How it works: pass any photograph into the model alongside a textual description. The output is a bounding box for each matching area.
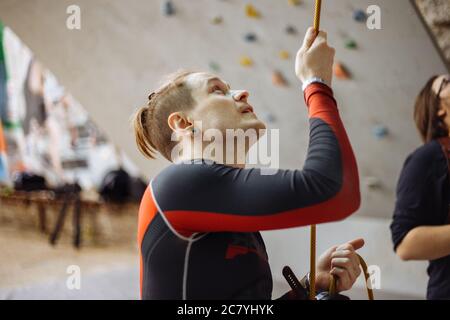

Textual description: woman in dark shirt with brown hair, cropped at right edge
[391,75,450,299]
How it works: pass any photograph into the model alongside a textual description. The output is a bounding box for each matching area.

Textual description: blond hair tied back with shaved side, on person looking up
[132,70,194,161]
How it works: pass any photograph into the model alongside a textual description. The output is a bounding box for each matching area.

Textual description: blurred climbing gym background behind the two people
[0,0,450,299]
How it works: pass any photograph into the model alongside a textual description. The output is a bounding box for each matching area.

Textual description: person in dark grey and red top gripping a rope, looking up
[134,29,363,299]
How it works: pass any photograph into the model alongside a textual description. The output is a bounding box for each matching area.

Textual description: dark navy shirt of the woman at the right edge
[391,141,450,299]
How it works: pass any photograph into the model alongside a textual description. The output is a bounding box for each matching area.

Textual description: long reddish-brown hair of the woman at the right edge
[414,76,448,143]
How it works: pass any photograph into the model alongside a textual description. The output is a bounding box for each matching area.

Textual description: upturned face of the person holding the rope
[186,73,266,137]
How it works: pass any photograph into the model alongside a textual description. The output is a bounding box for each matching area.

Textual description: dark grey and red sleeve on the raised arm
[152,84,360,233]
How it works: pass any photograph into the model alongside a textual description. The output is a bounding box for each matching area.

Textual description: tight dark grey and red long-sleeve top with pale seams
[138,83,360,300]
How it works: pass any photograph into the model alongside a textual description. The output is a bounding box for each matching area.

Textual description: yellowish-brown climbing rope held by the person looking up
[309,0,374,300]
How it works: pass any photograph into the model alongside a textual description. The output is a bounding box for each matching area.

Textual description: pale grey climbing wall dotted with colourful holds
[0,0,447,217]
